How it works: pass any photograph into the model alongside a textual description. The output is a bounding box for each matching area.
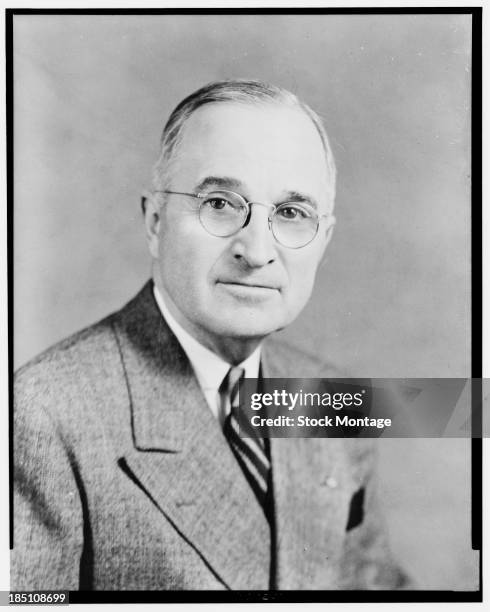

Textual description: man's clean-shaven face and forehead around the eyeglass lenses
[146,103,332,347]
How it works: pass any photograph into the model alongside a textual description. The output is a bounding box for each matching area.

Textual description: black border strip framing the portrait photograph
[5,6,483,604]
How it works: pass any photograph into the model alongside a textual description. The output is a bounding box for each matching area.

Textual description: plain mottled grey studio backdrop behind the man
[14,14,477,589]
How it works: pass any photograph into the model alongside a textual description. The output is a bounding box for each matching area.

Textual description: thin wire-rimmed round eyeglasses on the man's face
[155,190,335,249]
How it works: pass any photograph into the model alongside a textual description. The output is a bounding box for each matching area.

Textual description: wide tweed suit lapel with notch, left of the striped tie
[115,283,270,589]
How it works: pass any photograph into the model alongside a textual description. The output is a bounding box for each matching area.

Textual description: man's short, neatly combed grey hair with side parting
[153,79,337,200]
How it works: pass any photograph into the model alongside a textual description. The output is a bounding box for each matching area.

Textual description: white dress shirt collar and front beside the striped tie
[153,283,260,424]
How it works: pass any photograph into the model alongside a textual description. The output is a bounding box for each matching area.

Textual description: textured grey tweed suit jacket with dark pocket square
[11,283,410,590]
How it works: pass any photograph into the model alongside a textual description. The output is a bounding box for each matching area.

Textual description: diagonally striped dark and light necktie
[219,368,270,511]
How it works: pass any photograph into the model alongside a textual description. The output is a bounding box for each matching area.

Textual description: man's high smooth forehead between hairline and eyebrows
[168,102,330,204]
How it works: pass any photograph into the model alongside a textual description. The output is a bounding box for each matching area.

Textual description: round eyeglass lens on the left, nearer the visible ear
[199,191,247,237]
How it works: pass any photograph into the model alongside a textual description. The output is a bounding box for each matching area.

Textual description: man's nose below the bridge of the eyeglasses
[231,203,277,268]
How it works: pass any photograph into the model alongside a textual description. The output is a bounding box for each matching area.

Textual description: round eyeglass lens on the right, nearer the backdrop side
[272,202,318,249]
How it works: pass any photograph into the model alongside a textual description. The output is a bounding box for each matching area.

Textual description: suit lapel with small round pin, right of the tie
[262,347,355,590]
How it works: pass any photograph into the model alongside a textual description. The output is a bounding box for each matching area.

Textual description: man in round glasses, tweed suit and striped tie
[12,80,410,590]
